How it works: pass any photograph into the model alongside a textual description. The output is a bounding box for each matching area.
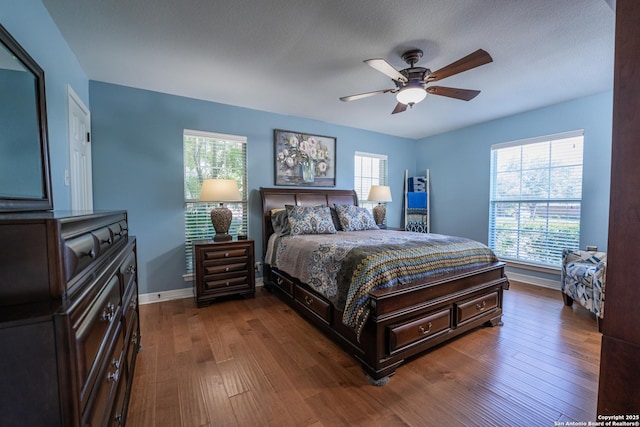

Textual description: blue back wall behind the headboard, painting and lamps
[89,81,416,293]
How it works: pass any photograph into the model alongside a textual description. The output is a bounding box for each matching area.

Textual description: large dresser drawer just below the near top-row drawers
[71,275,122,405]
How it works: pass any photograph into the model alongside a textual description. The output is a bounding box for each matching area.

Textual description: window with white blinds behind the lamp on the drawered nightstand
[183,130,248,274]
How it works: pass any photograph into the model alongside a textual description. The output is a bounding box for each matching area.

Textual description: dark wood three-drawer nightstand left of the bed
[193,240,256,307]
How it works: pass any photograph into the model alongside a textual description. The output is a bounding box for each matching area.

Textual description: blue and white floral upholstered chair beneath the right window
[560,249,607,331]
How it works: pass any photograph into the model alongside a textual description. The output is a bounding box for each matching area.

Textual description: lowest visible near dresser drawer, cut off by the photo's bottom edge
[82,323,126,426]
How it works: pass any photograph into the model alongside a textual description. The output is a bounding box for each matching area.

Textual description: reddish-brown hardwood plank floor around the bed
[127,281,601,427]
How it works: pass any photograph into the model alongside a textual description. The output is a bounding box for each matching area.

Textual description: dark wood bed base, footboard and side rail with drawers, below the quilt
[264,262,509,381]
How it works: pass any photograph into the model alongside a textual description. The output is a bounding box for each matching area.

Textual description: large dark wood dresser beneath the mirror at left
[0,211,140,427]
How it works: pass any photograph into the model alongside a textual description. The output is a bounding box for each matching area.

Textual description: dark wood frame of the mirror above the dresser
[0,24,53,212]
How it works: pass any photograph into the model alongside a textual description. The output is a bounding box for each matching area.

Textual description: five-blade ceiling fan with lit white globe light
[340,49,493,114]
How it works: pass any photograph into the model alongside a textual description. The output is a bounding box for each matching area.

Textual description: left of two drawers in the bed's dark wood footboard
[389,308,451,354]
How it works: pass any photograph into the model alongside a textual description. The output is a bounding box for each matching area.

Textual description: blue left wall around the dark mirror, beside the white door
[0,0,89,210]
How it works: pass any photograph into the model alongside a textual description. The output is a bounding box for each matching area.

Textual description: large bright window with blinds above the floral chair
[489,131,583,267]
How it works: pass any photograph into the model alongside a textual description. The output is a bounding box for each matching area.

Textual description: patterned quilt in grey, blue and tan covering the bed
[265,230,498,337]
